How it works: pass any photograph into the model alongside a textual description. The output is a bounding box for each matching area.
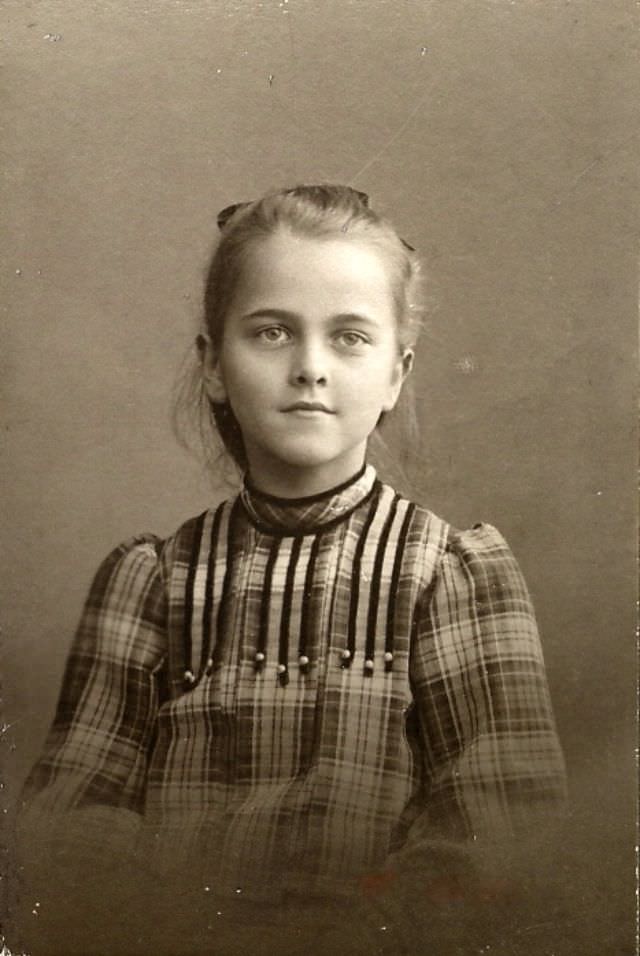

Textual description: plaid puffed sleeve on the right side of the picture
[388,524,566,888]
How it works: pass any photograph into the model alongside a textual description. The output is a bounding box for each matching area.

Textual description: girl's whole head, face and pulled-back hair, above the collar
[178,186,419,493]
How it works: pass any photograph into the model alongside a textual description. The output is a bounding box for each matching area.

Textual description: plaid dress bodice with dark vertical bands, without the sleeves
[146,470,448,898]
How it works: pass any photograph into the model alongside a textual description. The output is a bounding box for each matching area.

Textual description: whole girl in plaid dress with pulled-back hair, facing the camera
[15,186,564,954]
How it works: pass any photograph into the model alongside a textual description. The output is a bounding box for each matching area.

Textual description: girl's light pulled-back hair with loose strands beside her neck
[174,185,421,486]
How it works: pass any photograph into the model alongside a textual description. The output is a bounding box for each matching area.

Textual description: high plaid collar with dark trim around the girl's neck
[240,465,377,534]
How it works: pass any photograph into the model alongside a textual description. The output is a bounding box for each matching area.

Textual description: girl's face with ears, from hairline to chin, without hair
[205,231,412,497]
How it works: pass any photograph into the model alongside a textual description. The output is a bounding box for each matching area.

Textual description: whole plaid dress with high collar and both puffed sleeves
[24,466,565,899]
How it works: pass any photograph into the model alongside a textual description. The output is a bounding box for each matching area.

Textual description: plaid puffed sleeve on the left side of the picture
[18,535,166,872]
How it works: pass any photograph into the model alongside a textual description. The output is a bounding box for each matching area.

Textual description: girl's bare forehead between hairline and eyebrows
[234,231,393,311]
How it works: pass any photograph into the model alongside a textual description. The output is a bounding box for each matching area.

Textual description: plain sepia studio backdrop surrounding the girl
[0,0,639,956]
